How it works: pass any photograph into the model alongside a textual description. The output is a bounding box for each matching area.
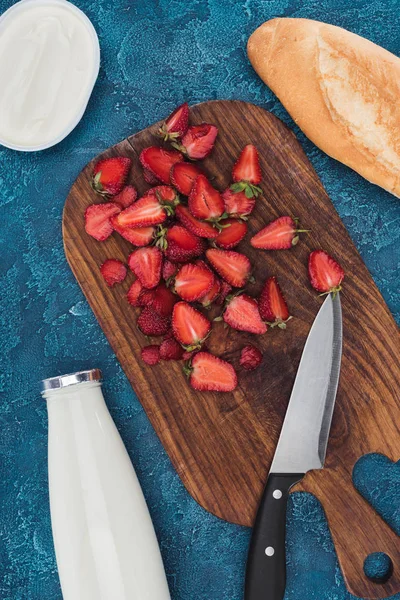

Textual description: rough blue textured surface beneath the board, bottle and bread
[0,0,400,600]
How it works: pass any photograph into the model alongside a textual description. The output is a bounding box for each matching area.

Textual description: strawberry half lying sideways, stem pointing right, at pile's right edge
[250,216,308,250]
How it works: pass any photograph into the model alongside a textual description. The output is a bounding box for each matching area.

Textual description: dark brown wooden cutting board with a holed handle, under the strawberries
[63,101,400,598]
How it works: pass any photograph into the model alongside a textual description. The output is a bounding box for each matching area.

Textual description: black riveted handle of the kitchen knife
[244,473,304,600]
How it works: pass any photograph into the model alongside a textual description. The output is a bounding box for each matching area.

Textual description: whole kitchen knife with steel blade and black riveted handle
[245,294,342,600]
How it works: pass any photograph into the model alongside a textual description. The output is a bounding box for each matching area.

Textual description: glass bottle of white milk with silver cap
[42,369,170,600]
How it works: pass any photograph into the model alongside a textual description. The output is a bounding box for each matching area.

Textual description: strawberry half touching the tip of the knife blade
[308,250,344,297]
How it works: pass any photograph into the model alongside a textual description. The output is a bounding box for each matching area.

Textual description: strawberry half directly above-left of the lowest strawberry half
[172,302,211,351]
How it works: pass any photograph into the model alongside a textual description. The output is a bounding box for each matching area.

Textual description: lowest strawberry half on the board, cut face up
[185,352,237,392]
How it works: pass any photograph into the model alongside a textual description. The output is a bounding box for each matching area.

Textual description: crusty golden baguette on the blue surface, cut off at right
[247,19,400,196]
